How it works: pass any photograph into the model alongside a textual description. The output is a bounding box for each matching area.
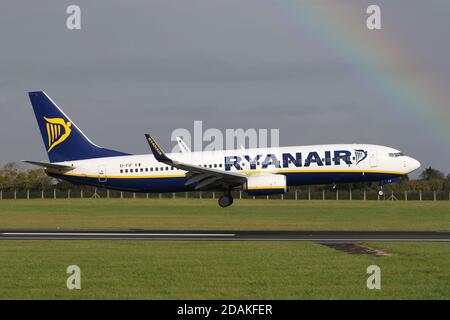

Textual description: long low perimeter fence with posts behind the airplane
[0,188,450,201]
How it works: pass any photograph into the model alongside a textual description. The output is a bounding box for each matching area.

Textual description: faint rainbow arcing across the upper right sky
[274,0,450,155]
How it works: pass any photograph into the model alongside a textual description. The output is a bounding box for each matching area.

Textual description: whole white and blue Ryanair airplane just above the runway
[24,91,420,207]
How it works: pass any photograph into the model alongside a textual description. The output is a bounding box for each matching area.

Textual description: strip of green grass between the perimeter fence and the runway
[0,199,450,231]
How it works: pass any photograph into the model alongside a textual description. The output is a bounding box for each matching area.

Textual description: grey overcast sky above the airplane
[0,0,450,173]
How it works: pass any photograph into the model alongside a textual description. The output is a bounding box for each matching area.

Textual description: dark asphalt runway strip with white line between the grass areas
[0,230,450,243]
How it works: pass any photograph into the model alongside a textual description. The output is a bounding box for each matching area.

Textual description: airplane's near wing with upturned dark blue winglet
[145,134,247,189]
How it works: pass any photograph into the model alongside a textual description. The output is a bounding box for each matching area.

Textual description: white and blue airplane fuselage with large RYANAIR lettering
[46,144,420,193]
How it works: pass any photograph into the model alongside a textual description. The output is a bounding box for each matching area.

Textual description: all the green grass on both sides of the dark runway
[0,199,450,299]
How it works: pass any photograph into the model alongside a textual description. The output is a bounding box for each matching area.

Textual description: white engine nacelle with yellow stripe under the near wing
[244,174,287,196]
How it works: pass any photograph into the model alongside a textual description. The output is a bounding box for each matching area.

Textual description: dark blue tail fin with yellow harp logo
[28,91,127,162]
